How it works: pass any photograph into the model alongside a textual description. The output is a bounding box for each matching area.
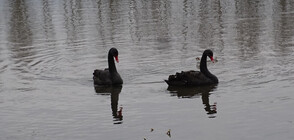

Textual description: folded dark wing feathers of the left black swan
[93,69,111,85]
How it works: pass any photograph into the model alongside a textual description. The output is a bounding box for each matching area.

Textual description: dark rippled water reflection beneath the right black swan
[167,85,217,118]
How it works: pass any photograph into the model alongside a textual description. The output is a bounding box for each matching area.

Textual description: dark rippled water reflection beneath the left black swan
[94,85,123,124]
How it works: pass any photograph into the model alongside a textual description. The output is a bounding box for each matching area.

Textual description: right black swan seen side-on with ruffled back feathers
[165,49,218,86]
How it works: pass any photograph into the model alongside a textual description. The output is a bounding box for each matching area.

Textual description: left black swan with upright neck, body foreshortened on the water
[93,48,123,85]
